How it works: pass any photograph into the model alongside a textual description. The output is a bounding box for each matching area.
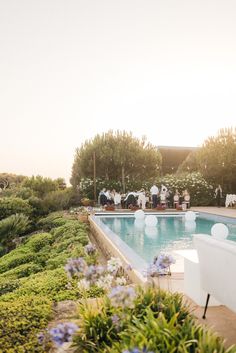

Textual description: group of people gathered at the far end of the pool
[98,184,190,209]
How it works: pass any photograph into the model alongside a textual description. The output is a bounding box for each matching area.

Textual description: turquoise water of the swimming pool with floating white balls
[100,216,236,263]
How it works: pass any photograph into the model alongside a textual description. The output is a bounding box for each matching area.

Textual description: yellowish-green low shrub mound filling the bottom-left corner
[0,296,52,353]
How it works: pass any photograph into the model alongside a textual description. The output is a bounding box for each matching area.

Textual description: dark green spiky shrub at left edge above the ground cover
[0,214,29,251]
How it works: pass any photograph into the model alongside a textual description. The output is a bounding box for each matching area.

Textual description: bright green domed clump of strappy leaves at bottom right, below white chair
[109,308,235,353]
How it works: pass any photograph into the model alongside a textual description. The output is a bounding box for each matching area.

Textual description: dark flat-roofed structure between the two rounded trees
[158,146,198,175]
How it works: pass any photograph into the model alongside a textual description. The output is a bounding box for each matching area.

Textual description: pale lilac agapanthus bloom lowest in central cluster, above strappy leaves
[108,286,136,308]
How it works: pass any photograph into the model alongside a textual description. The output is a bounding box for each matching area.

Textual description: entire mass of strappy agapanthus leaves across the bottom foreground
[74,288,235,353]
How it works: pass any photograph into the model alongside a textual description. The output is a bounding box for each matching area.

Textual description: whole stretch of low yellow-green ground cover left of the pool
[0,210,96,353]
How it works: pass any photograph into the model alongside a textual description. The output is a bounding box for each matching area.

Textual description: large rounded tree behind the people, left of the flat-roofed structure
[71,131,161,190]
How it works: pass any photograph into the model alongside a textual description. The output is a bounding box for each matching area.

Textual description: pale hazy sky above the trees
[0,0,236,182]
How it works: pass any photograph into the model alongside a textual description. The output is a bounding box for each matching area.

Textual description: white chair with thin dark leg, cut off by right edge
[193,234,236,319]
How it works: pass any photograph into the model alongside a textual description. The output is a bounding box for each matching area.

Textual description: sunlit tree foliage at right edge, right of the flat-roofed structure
[180,128,236,193]
